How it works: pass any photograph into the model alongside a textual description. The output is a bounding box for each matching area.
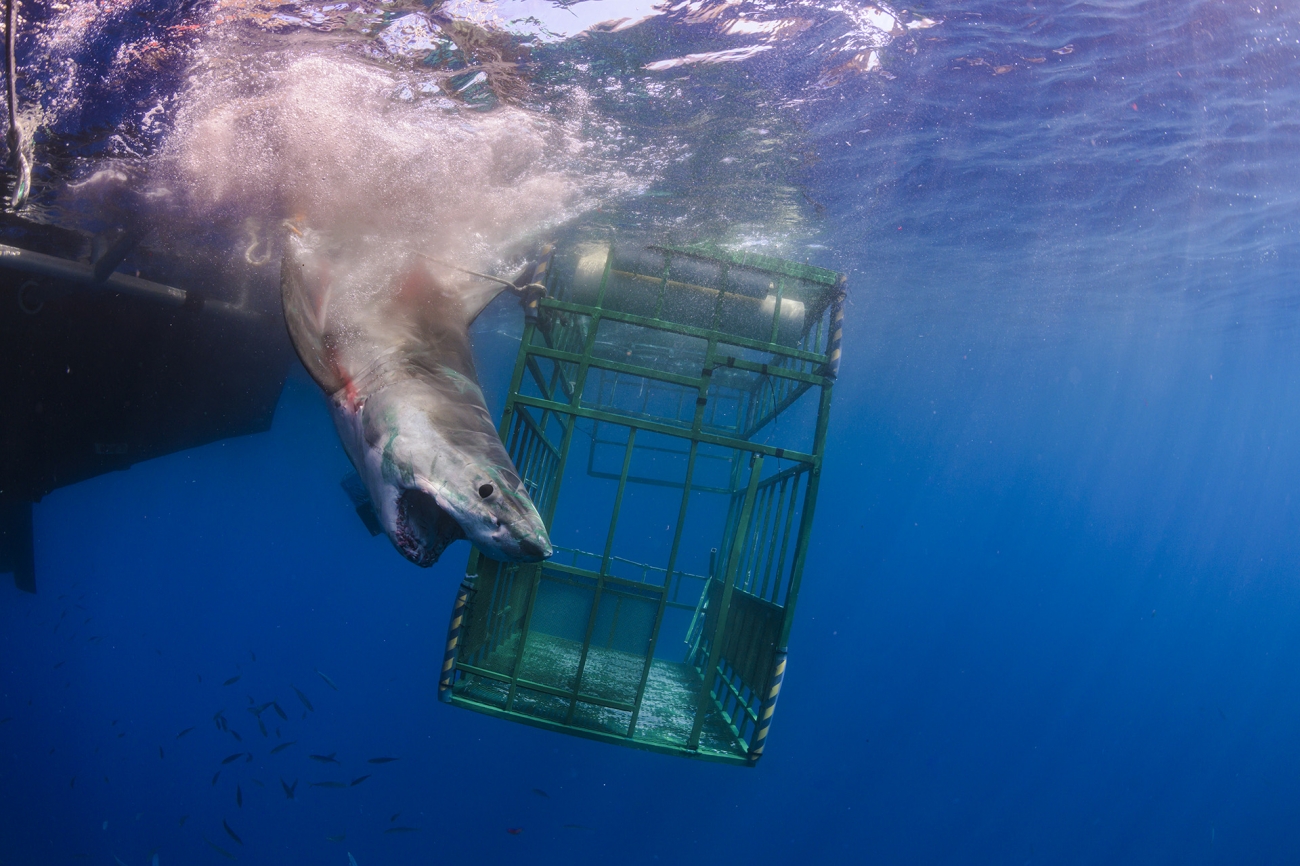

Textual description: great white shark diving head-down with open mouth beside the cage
[281,230,551,567]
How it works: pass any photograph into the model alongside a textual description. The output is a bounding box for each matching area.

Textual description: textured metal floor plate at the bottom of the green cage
[456,633,744,755]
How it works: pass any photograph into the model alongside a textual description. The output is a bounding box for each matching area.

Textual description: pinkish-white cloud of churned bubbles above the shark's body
[161,53,584,267]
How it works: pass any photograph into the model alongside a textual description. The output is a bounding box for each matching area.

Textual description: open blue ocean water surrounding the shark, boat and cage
[0,0,1300,866]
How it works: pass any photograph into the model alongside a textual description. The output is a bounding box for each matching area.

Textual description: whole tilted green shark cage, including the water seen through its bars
[438,242,845,765]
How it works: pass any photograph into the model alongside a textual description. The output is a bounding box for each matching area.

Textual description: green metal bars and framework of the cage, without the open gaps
[438,242,846,766]
